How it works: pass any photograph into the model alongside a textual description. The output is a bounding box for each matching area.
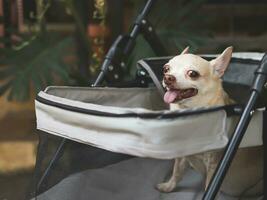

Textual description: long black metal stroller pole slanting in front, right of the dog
[202,54,267,200]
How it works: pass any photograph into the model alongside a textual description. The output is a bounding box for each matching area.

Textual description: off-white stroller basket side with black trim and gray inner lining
[36,87,262,159]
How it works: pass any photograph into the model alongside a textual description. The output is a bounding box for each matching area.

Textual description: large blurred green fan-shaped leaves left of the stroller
[0,0,89,101]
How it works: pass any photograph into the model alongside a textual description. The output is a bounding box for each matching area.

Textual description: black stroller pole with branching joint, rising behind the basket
[92,0,167,86]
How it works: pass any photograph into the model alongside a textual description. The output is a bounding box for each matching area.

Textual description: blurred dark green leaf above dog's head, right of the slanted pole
[151,0,208,50]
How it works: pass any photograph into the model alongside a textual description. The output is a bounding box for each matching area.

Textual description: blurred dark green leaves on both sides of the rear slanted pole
[128,0,209,76]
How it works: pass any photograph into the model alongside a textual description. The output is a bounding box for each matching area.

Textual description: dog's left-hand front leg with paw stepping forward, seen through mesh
[157,157,187,192]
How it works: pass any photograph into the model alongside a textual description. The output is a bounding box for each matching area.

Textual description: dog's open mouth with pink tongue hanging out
[164,88,198,103]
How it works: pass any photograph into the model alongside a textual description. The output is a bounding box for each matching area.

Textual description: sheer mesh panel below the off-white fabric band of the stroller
[27,132,262,200]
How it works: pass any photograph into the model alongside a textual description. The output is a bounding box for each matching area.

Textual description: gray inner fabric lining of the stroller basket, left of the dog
[45,86,168,110]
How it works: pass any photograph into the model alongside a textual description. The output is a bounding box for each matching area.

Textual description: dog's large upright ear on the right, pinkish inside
[210,47,233,77]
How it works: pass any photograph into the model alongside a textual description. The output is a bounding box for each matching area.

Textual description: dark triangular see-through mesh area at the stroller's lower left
[29,131,131,198]
